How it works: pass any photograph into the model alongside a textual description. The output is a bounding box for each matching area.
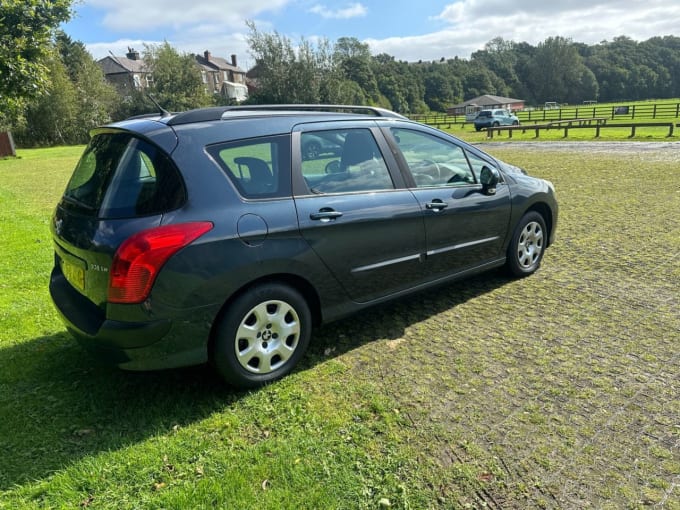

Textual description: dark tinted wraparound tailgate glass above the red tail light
[64,133,186,219]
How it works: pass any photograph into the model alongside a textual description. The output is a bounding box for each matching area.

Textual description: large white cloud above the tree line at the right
[364,0,680,61]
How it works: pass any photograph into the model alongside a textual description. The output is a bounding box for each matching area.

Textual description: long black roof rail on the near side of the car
[168,104,406,126]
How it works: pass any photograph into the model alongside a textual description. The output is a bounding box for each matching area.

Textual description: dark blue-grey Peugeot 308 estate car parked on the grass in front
[50,105,557,387]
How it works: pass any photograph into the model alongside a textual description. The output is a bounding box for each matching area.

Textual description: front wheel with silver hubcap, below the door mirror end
[507,211,547,277]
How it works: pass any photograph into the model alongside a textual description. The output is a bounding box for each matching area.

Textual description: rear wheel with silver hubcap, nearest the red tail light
[211,283,312,388]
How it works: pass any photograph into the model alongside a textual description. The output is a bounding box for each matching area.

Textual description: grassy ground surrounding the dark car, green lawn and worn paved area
[0,141,680,509]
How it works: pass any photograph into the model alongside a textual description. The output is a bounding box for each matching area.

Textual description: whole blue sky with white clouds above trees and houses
[64,0,680,68]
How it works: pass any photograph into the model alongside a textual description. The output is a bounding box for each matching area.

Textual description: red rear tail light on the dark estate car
[108,221,213,303]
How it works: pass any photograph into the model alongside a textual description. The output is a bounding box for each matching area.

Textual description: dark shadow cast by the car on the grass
[0,271,511,490]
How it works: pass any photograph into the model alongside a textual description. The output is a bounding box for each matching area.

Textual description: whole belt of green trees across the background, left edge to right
[0,0,680,146]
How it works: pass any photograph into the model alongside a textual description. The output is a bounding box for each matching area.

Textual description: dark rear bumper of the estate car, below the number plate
[50,268,216,370]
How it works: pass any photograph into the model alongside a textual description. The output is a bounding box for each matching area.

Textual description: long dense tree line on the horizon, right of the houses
[249,29,680,114]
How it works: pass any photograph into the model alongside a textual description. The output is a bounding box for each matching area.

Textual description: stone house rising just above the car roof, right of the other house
[195,50,248,102]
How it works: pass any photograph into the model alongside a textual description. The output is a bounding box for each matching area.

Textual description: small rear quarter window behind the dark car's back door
[208,135,291,198]
